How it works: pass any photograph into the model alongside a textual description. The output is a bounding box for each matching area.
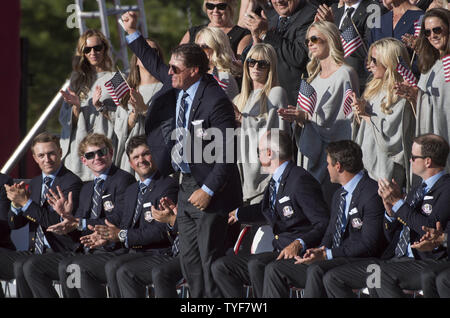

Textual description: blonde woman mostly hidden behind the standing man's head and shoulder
[195,27,242,100]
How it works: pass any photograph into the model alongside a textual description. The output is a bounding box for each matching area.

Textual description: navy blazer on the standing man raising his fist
[129,36,242,213]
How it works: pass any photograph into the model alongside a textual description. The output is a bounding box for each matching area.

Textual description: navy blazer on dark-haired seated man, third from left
[107,172,178,250]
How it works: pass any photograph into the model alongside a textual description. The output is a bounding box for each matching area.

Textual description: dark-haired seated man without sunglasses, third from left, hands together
[48,136,178,298]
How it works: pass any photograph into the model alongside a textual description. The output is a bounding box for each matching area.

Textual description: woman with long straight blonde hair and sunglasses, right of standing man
[233,43,289,204]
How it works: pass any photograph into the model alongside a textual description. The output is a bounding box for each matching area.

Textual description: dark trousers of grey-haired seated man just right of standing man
[212,252,279,298]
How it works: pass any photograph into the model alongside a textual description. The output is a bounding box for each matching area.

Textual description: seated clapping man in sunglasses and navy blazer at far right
[324,134,450,297]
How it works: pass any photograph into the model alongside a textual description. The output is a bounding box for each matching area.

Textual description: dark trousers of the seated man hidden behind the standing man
[117,255,183,298]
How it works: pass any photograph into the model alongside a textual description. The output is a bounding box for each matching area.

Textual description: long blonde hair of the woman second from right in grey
[363,38,411,114]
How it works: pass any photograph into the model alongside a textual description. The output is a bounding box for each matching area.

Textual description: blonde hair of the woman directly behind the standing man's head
[195,27,241,76]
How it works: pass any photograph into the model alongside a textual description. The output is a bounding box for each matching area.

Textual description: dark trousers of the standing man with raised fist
[177,175,230,298]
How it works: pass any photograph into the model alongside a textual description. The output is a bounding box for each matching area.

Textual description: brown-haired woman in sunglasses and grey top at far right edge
[397,8,450,169]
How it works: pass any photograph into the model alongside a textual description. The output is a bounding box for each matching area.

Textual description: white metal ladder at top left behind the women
[75,0,147,72]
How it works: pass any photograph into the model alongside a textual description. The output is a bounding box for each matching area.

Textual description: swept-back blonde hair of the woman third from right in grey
[306,21,344,83]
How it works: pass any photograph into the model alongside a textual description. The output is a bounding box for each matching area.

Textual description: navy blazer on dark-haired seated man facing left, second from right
[321,172,386,258]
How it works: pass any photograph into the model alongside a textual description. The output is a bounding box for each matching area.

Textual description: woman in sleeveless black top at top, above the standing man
[180,0,251,58]
